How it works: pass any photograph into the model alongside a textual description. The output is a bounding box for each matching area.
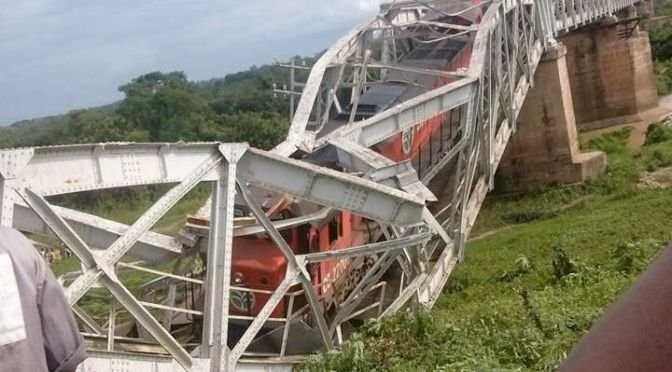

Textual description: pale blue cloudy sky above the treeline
[0,0,383,126]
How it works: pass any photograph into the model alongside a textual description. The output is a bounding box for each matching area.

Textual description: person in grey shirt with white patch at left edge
[0,227,86,372]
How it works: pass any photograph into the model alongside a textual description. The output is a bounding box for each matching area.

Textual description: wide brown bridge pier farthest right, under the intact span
[561,22,658,130]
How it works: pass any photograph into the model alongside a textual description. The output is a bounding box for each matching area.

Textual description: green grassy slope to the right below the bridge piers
[302,126,672,371]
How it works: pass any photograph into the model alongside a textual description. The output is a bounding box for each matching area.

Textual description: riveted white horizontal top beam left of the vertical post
[9,143,219,196]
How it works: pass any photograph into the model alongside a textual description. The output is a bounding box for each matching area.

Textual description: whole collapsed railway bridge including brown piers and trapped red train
[0,0,657,372]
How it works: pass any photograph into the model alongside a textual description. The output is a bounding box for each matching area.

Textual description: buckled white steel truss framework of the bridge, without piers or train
[0,0,638,371]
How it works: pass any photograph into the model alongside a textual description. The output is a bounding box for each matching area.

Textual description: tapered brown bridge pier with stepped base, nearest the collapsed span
[495,44,607,191]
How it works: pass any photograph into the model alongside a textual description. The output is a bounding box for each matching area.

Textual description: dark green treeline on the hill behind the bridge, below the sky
[0,57,313,149]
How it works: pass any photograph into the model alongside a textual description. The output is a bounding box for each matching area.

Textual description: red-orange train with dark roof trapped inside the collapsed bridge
[181,1,481,346]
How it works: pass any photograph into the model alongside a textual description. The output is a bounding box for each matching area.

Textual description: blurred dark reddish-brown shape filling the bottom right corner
[560,246,672,372]
